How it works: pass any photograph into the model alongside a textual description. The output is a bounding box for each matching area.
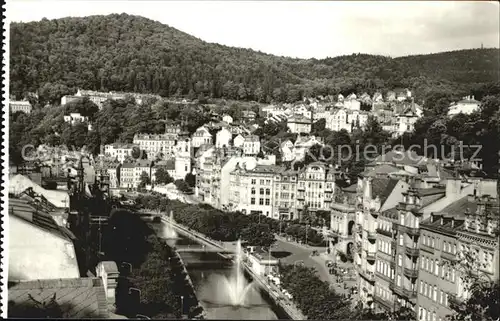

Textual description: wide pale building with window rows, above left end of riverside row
[133,133,177,159]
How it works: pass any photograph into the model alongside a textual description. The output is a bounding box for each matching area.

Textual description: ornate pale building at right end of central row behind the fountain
[296,162,339,218]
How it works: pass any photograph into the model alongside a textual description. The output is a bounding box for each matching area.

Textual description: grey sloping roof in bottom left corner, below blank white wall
[8,278,109,318]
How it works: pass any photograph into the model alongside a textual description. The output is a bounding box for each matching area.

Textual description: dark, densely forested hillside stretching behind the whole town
[10,14,500,104]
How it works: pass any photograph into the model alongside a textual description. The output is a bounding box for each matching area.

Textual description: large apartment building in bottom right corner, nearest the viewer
[417,195,499,321]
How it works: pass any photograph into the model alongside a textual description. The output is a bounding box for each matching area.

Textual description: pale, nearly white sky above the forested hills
[6,0,500,59]
